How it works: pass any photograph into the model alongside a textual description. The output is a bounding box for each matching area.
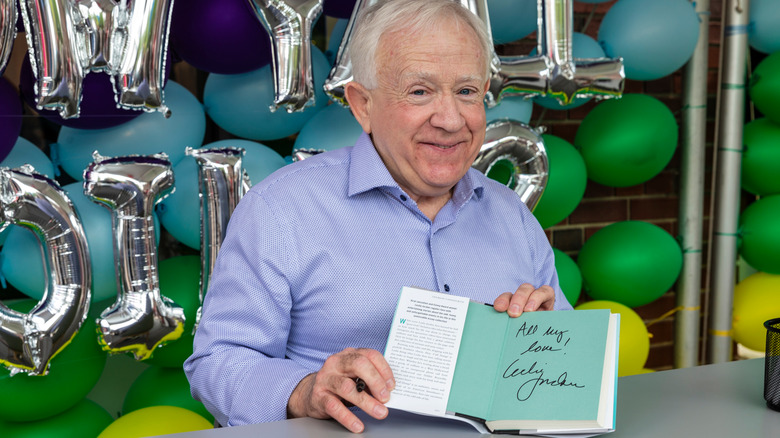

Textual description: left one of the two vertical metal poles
[674,0,710,368]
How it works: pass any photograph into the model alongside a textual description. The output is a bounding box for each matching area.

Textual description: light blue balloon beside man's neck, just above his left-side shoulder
[293,103,363,151]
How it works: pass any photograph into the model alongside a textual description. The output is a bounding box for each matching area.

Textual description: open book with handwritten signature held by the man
[385,287,620,436]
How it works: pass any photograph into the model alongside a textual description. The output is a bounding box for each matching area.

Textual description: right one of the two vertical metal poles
[708,0,750,363]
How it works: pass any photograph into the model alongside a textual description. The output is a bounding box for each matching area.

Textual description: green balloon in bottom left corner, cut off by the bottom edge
[0,399,114,438]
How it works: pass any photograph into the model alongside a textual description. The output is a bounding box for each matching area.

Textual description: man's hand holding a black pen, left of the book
[287,348,395,433]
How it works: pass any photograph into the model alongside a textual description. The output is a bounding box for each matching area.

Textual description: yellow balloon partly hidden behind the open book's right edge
[575,300,650,376]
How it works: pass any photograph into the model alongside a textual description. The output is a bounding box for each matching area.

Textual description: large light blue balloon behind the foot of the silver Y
[203,46,330,140]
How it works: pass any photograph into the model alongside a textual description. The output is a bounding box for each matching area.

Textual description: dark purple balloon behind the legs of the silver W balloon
[19,56,143,129]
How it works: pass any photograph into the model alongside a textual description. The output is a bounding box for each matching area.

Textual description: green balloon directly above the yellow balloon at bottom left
[122,367,214,422]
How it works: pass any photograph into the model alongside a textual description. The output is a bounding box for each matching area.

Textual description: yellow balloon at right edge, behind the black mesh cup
[731,272,780,351]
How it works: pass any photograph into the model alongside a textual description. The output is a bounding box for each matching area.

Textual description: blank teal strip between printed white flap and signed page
[447,301,509,420]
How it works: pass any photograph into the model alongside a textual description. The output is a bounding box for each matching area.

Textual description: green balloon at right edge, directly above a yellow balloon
[739,195,780,274]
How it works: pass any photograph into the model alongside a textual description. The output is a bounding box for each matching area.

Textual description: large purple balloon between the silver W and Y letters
[169,0,271,74]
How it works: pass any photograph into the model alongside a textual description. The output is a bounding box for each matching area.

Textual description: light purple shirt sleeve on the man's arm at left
[184,191,312,426]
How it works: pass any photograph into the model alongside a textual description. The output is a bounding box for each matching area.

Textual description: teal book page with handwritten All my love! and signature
[488,309,610,421]
